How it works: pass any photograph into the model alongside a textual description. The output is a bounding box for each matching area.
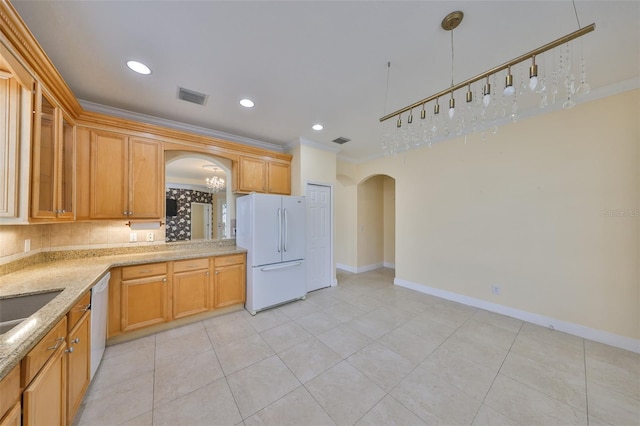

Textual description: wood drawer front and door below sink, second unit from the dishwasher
[21,317,67,426]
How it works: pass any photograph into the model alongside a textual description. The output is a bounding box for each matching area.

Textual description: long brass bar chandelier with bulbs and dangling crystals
[380,9,595,156]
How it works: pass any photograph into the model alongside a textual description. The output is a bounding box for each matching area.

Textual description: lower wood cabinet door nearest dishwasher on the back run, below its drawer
[121,275,168,331]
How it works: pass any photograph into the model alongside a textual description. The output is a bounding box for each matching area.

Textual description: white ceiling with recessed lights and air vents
[12,0,640,161]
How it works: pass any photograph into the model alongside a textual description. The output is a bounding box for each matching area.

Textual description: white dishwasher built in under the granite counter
[91,272,111,380]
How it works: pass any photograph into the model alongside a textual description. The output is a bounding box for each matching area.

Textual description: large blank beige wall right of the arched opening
[337,90,640,339]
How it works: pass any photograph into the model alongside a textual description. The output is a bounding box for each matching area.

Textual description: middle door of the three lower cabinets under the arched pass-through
[172,270,211,319]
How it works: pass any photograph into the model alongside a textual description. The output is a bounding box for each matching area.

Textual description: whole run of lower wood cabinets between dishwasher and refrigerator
[107,253,246,338]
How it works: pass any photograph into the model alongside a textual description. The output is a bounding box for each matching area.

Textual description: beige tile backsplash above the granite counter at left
[0,221,165,264]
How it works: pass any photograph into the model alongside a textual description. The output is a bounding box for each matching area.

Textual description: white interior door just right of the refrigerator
[306,183,333,291]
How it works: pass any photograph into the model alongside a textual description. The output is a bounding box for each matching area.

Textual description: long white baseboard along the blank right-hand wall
[393,278,640,353]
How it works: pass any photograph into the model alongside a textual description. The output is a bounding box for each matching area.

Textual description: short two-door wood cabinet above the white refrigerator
[232,156,291,195]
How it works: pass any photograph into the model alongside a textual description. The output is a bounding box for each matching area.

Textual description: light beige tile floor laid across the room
[75,269,640,426]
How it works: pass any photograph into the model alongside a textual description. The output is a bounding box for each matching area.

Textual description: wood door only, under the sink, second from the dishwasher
[22,344,67,426]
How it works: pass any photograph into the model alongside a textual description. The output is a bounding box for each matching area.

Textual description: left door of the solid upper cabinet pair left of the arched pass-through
[89,131,129,219]
